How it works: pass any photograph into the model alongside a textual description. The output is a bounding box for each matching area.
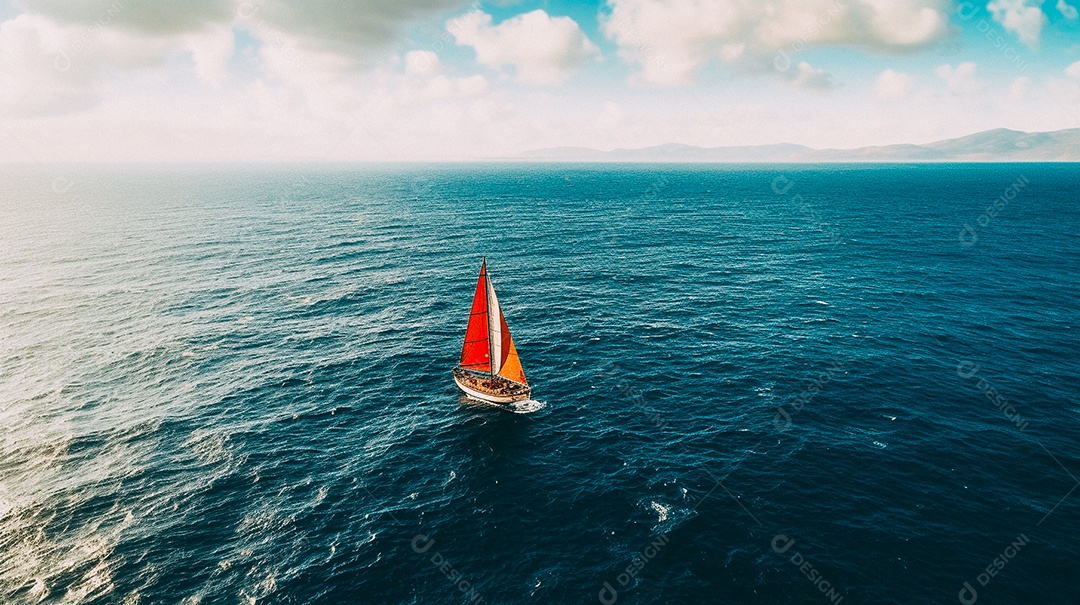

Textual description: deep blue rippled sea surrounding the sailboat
[0,164,1080,605]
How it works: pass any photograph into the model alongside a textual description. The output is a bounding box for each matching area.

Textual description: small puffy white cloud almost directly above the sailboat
[446,10,599,83]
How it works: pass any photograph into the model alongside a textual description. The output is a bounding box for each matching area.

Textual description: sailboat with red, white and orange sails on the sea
[454,258,532,404]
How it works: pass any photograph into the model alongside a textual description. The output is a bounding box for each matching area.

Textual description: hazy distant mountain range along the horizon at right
[513,129,1080,162]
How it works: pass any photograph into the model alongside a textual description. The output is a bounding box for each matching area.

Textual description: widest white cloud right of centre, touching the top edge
[603,0,950,84]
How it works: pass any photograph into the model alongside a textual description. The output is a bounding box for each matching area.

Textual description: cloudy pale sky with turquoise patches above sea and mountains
[0,0,1080,162]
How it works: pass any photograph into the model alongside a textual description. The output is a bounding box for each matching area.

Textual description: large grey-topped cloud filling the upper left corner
[0,0,479,115]
